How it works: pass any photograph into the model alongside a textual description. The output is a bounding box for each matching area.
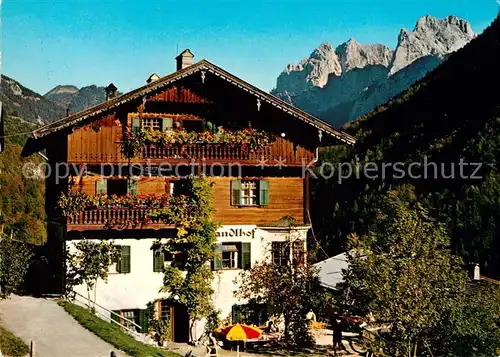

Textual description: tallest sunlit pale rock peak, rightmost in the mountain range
[390,15,476,75]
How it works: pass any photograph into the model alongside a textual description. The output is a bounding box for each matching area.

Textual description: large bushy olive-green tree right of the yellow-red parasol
[347,187,467,356]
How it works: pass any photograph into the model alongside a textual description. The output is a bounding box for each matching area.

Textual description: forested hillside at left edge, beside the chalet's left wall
[0,116,47,244]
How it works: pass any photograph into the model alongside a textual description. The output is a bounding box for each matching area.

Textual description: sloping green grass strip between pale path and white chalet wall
[58,301,179,357]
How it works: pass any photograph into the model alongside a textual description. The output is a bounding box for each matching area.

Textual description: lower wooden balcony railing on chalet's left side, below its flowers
[67,208,174,231]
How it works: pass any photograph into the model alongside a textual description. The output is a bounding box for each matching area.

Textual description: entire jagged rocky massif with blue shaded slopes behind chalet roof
[272,15,476,127]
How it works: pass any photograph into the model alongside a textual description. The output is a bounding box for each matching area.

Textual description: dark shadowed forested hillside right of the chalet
[312,18,500,277]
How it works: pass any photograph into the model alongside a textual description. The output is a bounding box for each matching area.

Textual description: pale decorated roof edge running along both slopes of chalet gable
[33,60,356,144]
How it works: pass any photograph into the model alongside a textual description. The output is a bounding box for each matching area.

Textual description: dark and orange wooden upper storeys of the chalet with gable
[24,55,354,292]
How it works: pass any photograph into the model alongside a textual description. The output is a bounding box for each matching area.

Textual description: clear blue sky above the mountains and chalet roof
[2,0,498,94]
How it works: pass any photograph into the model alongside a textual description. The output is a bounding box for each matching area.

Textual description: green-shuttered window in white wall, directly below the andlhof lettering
[213,242,251,270]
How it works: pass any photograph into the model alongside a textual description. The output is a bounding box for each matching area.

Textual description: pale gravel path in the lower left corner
[0,295,126,357]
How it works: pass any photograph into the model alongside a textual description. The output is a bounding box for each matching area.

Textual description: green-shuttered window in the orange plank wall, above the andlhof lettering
[231,180,269,206]
